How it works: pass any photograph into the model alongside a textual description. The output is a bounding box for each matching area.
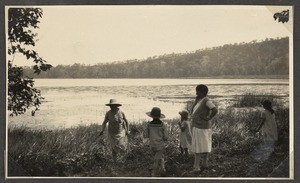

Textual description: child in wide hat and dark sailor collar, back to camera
[146,107,168,176]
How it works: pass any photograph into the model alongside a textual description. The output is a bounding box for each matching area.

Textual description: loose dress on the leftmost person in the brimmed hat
[105,110,128,150]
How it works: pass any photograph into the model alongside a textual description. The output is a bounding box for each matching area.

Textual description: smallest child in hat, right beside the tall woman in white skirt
[178,110,192,156]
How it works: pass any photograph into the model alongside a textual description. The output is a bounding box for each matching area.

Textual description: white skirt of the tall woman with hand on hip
[191,127,212,153]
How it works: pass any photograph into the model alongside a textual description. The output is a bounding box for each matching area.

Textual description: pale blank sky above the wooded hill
[7,5,293,66]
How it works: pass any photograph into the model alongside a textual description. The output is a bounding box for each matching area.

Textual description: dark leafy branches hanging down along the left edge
[7,8,52,116]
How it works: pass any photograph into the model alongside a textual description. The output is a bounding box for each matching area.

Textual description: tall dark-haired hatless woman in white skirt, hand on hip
[191,84,218,172]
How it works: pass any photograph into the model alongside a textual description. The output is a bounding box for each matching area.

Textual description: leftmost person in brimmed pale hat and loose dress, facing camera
[100,99,129,162]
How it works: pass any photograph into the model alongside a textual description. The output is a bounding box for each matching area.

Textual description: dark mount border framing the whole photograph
[0,0,300,183]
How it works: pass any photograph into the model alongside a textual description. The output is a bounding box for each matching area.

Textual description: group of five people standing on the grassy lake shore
[100,84,277,176]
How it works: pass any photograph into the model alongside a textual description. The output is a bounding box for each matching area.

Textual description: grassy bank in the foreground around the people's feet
[8,95,289,177]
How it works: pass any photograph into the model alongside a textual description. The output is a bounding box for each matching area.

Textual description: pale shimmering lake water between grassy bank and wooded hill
[8,79,289,129]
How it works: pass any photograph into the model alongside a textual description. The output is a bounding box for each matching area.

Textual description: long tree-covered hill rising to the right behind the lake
[24,38,289,78]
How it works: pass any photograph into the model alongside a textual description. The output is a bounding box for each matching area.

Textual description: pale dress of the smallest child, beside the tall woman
[179,120,192,149]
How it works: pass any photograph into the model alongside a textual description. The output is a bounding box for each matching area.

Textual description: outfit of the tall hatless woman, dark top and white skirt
[191,97,216,153]
